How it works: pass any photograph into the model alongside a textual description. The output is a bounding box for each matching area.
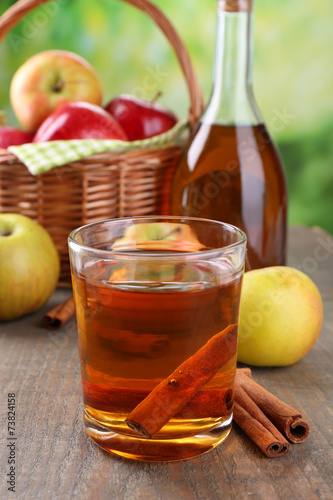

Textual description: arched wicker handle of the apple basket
[0,0,204,125]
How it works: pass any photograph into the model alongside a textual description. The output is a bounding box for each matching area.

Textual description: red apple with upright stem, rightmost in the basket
[105,94,177,141]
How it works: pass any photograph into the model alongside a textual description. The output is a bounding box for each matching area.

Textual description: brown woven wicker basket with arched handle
[0,0,203,286]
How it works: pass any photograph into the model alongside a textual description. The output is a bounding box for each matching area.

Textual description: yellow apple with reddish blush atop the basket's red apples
[10,50,102,132]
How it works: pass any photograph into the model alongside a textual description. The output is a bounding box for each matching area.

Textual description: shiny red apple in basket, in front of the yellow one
[33,102,128,142]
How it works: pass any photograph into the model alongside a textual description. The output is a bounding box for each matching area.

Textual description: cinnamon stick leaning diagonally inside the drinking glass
[125,325,238,438]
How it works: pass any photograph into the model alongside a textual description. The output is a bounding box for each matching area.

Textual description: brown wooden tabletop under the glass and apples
[0,227,333,500]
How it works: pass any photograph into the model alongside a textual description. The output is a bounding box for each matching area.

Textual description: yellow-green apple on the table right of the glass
[238,266,323,366]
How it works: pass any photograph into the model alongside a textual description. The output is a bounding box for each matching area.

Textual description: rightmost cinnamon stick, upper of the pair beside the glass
[236,372,310,443]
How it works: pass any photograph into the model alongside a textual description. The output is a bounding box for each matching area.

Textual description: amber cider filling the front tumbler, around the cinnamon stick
[73,261,241,461]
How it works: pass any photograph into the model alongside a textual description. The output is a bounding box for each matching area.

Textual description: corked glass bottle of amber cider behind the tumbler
[171,0,287,269]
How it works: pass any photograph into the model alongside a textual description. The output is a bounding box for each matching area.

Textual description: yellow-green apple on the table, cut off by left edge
[0,214,60,320]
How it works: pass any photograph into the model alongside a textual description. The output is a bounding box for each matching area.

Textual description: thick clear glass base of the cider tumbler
[84,413,232,462]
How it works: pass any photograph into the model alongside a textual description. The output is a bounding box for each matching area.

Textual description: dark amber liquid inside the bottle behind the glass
[171,123,287,269]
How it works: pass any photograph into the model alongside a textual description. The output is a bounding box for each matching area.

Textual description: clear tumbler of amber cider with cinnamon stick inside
[69,216,246,461]
